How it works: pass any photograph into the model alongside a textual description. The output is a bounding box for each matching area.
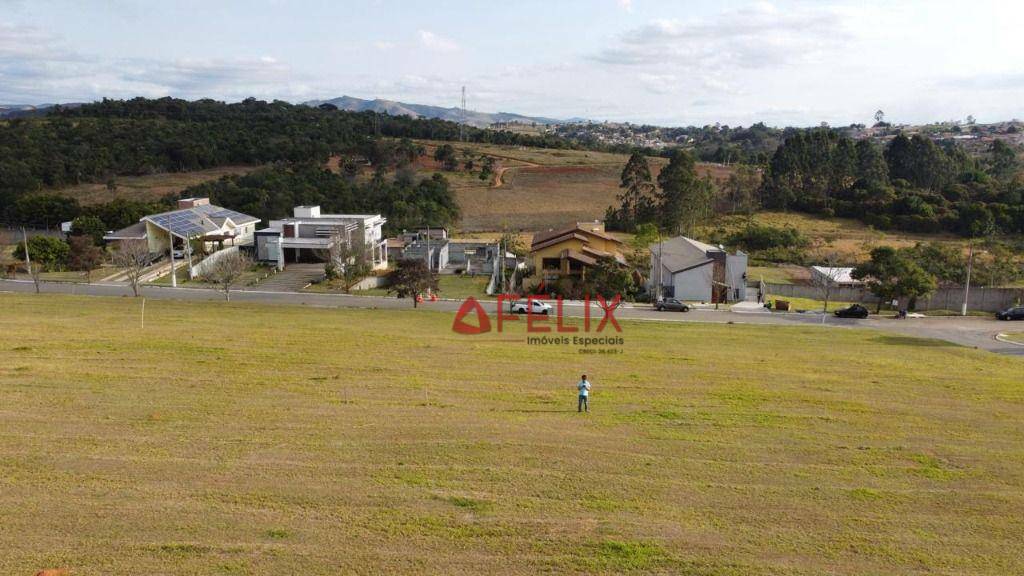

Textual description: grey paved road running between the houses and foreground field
[0,280,1024,357]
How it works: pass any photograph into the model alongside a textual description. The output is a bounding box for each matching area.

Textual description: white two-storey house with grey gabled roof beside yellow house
[648,236,746,303]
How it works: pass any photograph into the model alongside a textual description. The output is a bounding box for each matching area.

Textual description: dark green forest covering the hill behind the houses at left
[0,97,571,222]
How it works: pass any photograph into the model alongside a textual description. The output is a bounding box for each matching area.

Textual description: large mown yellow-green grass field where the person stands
[0,294,1024,575]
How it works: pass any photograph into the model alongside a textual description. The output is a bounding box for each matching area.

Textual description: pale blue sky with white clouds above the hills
[0,0,1024,126]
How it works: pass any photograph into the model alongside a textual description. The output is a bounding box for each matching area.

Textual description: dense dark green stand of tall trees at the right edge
[760,129,1024,237]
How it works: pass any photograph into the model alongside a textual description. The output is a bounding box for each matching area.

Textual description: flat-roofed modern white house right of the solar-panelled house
[254,206,387,270]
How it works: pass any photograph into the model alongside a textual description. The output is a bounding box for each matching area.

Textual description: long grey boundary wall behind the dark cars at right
[765,283,1024,312]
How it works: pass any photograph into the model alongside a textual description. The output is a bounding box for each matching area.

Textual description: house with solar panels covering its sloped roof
[103,198,260,254]
